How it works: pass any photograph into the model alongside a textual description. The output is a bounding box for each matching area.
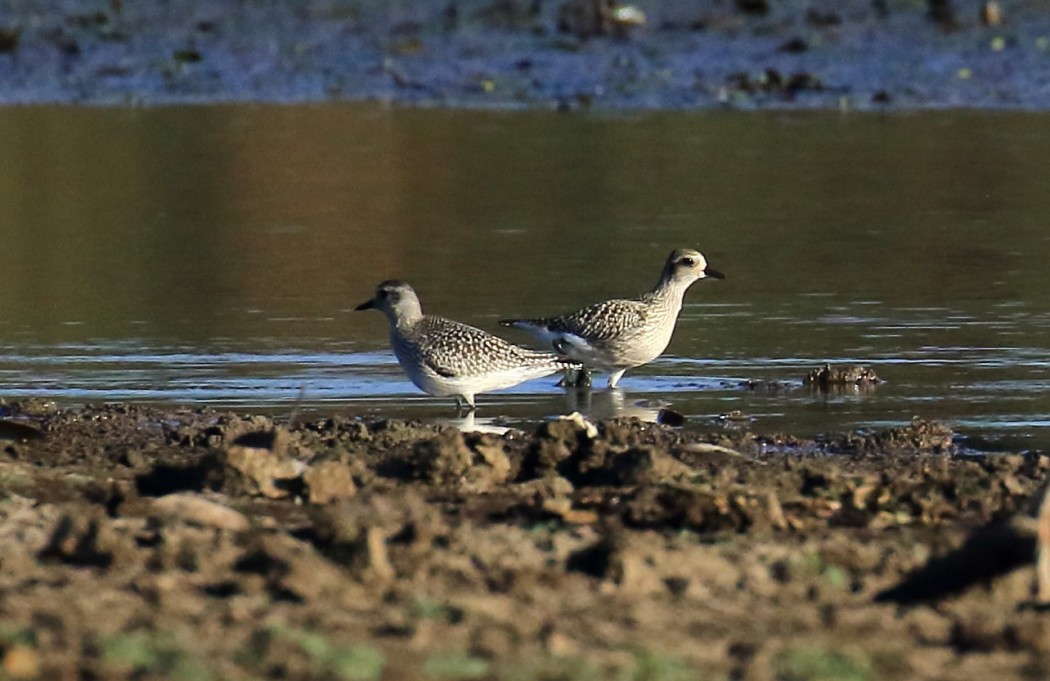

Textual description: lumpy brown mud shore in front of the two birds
[0,405,1050,679]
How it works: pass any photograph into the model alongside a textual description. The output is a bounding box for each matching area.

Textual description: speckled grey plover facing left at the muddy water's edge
[356,279,580,410]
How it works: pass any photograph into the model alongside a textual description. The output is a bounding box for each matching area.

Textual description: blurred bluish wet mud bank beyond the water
[0,0,1050,109]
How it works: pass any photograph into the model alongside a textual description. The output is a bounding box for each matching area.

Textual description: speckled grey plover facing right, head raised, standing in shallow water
[500,249,726,388]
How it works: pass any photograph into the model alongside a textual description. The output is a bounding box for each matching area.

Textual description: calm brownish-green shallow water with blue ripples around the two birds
[0,106,1050,449]
